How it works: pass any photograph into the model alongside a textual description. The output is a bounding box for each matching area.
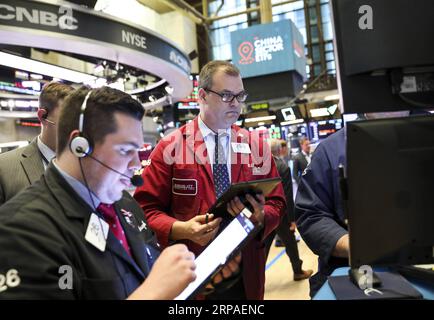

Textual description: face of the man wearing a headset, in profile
[86,113,143,203]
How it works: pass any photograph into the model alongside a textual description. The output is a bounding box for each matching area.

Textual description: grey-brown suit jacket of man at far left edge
[0,138,44,205]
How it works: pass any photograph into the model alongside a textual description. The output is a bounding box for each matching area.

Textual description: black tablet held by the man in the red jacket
[208,178,281,219]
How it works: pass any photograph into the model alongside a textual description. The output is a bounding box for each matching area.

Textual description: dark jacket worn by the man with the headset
[0,164,158,299]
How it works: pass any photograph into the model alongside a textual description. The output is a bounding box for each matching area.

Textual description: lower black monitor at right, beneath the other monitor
[346,115,434,268]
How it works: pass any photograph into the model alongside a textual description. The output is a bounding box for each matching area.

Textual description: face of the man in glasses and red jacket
[199,71,244,129]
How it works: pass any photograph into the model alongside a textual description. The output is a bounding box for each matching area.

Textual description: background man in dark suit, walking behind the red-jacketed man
[265,139,313,281]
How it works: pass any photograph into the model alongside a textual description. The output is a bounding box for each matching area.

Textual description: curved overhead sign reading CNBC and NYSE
[0,0,192,100]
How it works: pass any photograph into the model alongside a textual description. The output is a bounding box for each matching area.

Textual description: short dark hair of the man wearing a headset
[57,86,144,155]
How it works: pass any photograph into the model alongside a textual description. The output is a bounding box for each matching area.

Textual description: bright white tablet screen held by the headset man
[175,208,259,300]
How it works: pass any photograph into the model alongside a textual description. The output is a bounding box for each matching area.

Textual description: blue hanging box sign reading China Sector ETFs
[231,20,306,78]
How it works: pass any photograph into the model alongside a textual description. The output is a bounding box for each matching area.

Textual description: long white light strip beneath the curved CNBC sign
[0,52,97,83]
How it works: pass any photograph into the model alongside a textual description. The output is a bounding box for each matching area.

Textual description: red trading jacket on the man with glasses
[134,118,285,300]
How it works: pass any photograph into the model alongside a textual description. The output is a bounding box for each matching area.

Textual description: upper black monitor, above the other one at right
[331,0,434,113]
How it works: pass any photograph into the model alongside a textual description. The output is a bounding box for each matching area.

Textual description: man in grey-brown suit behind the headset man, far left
[0,82,74,205]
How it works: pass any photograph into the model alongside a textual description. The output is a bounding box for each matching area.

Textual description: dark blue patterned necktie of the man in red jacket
[213,134,231,199]
